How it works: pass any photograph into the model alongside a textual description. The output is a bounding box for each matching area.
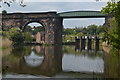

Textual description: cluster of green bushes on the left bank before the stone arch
[2,27,33,46]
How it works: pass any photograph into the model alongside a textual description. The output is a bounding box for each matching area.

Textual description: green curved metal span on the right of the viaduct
[58,11,106,18]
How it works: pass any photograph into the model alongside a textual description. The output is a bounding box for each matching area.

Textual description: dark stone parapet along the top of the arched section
[0,12,57,19]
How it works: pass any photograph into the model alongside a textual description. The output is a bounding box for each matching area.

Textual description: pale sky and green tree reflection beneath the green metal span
[62,46,104,73]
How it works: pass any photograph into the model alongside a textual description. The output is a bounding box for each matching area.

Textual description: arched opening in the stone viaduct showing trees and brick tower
[24,22,45,43]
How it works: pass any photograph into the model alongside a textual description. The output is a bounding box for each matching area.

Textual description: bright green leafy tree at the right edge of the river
[102,2,120,49]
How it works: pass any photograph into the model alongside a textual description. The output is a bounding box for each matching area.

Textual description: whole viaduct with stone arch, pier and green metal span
[1,11,107,44]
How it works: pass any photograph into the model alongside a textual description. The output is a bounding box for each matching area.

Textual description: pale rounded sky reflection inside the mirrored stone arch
[24,51,44,67]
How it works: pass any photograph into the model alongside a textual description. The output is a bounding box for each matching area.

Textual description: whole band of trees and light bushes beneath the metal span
[63,24,104,42]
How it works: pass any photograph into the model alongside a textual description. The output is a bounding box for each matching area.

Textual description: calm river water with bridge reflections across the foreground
[2,45,120,78]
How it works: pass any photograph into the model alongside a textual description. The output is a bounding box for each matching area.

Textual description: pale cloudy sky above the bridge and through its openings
[2,0,107,28]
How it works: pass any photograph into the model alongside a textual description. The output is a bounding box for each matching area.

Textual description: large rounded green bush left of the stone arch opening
[8,27,24,45]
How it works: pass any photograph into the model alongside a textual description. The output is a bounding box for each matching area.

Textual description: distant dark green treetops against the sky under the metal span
[63,25,104,35]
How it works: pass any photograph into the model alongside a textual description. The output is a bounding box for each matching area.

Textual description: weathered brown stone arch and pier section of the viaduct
[2,12,63,44]
